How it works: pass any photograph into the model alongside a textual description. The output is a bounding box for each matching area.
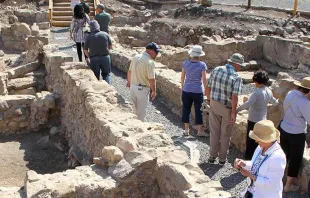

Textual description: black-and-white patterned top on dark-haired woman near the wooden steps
[70,14,90,43]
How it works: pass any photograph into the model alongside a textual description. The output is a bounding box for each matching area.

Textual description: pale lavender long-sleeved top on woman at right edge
[281,90,310,134]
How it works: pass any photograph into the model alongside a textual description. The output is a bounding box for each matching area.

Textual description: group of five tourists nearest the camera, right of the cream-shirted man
[181,45,310,198]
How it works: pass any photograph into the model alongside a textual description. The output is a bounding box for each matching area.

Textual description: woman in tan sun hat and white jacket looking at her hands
[234,120,286,198]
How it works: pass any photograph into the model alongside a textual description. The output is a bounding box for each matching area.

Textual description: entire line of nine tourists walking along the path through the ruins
[70,3,310,198]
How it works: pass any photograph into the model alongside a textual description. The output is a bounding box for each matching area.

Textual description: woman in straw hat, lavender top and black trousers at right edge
[279,77,310,192]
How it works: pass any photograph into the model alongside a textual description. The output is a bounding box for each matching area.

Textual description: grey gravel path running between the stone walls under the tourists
[51,29,305,198]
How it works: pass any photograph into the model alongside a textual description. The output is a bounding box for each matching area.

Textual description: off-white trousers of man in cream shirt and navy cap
[130,84,150,122]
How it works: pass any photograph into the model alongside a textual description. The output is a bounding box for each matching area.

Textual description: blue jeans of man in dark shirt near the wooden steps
[90,55,111,84]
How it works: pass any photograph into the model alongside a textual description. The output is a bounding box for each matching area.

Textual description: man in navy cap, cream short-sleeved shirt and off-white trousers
[126,42,161,121]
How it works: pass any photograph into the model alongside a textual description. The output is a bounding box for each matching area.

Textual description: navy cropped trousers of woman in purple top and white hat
[182,91,203,124]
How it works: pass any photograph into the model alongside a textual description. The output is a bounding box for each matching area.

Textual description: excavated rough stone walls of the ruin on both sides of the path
[0,1,310,198]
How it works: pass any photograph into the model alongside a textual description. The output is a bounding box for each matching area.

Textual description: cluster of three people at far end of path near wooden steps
[70,0,112,84]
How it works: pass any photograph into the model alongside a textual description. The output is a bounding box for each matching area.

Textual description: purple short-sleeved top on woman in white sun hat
[183,60,207,93]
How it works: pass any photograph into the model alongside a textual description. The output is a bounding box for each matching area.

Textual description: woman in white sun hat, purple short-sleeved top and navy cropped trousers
[181,45,207,136]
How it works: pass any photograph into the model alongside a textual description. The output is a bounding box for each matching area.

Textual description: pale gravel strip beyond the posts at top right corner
[213,0,310,11]
